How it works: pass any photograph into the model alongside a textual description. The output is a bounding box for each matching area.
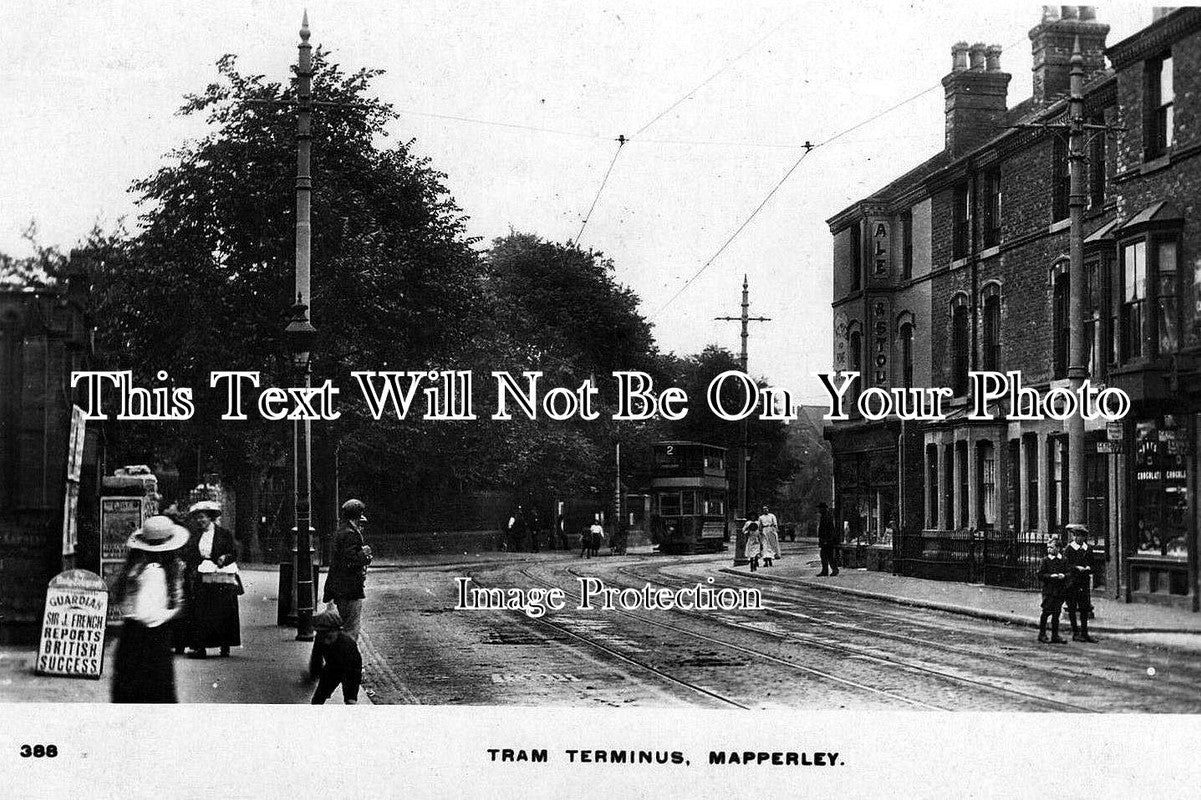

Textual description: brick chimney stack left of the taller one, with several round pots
[943,42,1011,156]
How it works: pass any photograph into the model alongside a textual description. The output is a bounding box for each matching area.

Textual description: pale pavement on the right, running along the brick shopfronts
[722,543,1201,644]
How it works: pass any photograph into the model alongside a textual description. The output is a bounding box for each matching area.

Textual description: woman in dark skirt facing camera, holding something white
[181,500,245,658]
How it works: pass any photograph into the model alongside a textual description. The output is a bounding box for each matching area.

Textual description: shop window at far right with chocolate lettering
[1130,414,1193,561]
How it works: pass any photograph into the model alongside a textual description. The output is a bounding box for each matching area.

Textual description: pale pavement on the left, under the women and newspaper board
[0,567,324,703]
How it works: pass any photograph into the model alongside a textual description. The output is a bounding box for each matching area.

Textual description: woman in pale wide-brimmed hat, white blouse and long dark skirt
[113,515,189,703]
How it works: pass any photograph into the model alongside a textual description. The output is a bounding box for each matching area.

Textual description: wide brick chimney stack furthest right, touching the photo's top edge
[1030,6,1110,106]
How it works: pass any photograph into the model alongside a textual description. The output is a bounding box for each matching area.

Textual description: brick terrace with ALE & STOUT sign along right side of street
[826,6,1201,610]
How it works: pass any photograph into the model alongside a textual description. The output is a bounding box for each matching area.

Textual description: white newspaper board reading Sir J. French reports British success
[35,569,108,679]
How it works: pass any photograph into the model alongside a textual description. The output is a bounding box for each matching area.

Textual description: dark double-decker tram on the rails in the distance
[651,442,729,553]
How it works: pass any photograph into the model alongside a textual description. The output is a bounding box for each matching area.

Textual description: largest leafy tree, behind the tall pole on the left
[89,49,486,547]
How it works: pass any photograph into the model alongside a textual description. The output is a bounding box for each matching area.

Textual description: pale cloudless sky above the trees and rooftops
[0,0,1151,400]
